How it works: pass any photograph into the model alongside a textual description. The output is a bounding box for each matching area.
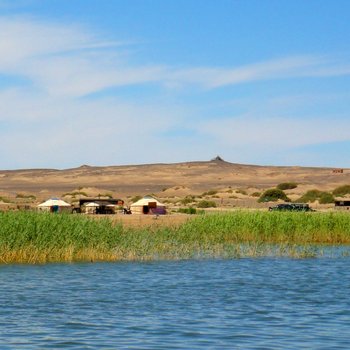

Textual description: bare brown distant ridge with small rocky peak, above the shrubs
[0,159,350,197]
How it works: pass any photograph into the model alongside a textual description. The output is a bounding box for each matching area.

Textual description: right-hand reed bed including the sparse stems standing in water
[172,211,350,257]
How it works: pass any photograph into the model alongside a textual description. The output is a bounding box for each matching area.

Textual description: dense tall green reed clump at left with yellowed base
[0,212,123,263]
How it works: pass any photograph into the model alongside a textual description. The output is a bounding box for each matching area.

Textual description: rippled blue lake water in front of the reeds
[0,258,350,350]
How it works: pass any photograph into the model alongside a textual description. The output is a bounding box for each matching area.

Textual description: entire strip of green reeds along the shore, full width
[0,211,350,263]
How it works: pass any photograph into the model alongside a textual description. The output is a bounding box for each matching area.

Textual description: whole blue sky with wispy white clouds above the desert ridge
[0,0,350,169]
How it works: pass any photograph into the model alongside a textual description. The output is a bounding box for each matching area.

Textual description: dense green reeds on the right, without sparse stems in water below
[179,211,350,244]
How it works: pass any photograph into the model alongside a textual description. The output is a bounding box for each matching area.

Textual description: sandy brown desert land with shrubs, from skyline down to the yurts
[0,159,350,208]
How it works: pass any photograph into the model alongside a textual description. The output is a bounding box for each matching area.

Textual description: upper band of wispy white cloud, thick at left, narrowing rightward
[0,17,350,96]
